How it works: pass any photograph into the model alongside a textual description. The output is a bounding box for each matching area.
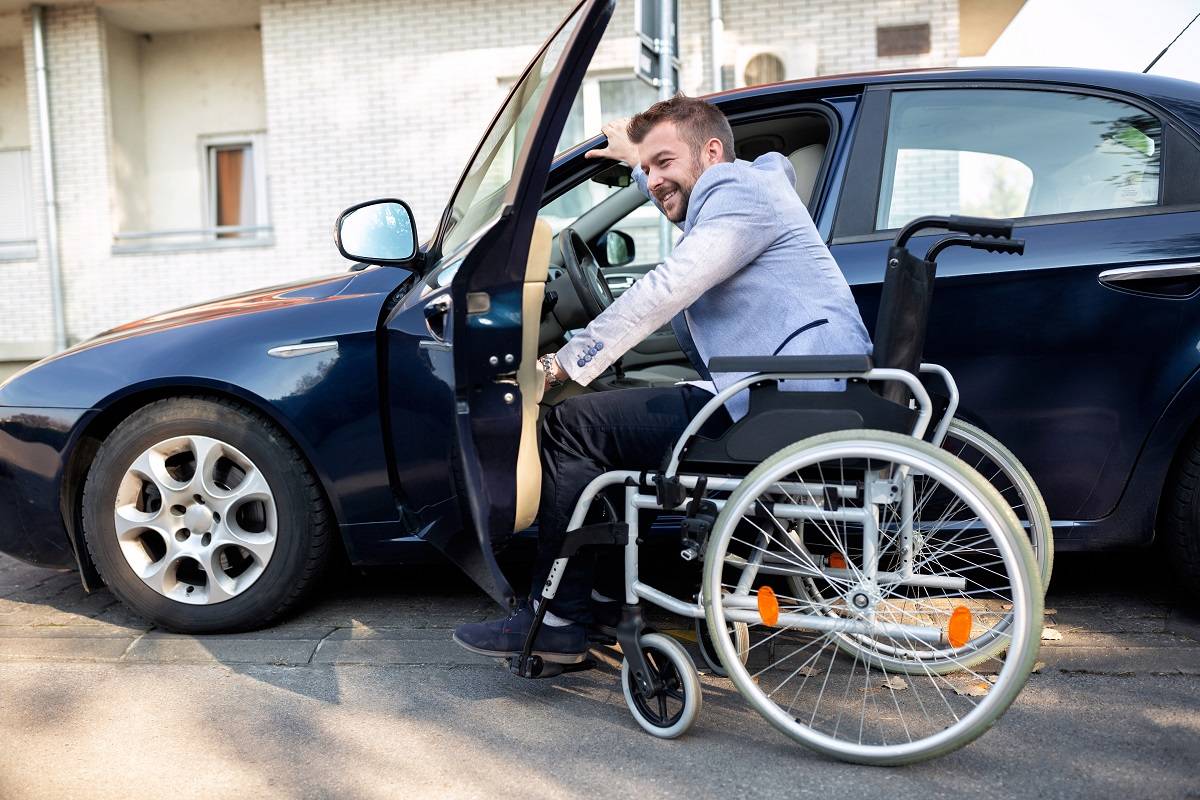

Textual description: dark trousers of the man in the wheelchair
[532,386,731,622]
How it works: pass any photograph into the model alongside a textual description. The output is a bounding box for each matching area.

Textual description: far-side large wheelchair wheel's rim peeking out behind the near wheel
[942,417,1054,590]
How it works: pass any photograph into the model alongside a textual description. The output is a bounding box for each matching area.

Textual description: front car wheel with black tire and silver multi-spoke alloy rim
[82,396,334,633]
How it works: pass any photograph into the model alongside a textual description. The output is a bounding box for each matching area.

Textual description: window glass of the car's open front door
[442,5,582,253]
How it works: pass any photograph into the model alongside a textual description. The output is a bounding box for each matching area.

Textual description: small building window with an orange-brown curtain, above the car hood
[200,136,268,239]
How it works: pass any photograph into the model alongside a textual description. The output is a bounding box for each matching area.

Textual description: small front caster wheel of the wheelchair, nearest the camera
[620,633,703,739]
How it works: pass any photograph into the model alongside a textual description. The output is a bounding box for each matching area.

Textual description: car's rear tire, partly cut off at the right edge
[1158,434,1200,607]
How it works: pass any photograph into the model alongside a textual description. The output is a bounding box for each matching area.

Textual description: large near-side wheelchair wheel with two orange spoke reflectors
[703,431,1042,764]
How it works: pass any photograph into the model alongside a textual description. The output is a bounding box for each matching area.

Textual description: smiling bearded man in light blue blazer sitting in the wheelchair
[455,95,871,663]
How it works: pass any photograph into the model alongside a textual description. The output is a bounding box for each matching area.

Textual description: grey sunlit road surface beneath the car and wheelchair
[0,554,1200,800]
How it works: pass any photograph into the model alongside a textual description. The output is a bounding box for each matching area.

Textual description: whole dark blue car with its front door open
[0,0,1200,632]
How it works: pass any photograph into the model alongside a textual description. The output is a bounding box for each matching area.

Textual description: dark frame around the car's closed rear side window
[830,80,1200,245]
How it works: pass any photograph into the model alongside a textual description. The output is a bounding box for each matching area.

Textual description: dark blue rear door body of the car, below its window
[833,206,1200,519]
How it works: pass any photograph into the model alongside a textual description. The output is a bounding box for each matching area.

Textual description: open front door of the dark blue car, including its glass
[431,0,616,604]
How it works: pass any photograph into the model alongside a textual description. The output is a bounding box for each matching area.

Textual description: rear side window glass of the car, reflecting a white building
[875,89,1163,230]
